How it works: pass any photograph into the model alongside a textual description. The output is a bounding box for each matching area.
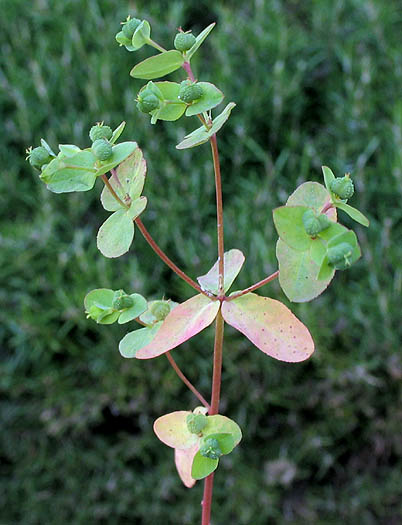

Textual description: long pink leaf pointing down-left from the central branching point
[135,294,220,359]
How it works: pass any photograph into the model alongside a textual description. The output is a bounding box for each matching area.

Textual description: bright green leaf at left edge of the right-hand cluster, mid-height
[272,205,312,252]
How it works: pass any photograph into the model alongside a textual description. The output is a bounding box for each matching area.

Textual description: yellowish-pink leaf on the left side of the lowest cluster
[154,410,200,450]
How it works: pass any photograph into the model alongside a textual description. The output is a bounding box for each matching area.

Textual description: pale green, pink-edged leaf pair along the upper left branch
[97,143,147,257]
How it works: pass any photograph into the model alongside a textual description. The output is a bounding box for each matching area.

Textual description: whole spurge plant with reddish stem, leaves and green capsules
[28,17,368,525]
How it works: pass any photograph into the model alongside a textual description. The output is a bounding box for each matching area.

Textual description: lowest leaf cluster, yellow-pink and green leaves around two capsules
[154,409,242,488]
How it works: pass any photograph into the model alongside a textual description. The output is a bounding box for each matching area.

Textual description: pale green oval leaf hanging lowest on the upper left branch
[96,209,134,258]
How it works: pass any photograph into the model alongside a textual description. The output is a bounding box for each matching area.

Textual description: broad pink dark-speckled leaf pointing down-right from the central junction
[222,293,314,363]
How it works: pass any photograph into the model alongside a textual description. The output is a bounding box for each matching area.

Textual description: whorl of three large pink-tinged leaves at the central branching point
[119,250,314,362]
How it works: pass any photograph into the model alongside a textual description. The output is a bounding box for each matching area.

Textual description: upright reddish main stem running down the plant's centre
[201,135,225,525]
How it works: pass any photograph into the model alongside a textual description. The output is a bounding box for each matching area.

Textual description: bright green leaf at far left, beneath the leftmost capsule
[40,150,96,193]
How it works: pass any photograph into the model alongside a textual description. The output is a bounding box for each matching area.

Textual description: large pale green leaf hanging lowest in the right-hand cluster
[276,239,335,303]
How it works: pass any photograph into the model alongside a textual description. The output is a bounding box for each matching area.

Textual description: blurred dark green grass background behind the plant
[0,0,402,525]
